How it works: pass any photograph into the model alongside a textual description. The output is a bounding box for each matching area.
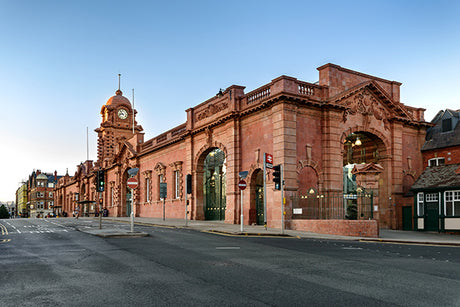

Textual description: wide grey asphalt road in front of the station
[0,218,460,306]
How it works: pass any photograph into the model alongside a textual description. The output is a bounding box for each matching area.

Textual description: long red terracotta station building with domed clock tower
[56,64,428,235]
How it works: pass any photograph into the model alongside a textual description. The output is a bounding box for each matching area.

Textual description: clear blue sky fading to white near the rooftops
[0,0,460,201]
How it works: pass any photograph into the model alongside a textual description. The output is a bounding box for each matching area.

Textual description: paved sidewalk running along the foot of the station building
[80,217,460,247]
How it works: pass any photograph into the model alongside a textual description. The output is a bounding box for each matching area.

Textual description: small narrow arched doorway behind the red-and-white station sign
[249,168,264,225]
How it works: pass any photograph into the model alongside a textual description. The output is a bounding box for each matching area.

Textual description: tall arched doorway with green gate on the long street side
[203,148,227,220]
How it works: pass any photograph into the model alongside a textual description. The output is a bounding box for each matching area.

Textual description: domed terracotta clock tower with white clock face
[95,89,143,166]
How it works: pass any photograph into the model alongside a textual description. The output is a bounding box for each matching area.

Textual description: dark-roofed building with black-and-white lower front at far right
[412,110,460,232]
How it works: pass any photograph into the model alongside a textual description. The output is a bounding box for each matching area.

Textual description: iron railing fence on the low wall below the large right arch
[291,190,375,220]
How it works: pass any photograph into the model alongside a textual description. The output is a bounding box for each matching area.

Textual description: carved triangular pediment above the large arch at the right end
[331,81,414,128]
